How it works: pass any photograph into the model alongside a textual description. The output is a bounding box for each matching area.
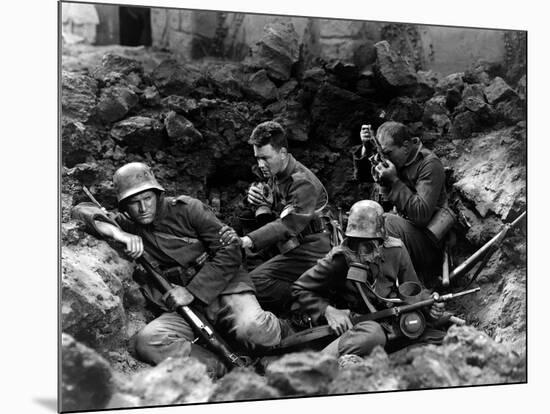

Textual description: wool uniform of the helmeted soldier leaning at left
[73,196,281,363]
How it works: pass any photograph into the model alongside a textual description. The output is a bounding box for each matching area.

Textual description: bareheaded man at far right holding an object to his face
[354,121,454,283]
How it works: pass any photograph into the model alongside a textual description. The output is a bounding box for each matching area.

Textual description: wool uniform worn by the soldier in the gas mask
[292,237,419,356]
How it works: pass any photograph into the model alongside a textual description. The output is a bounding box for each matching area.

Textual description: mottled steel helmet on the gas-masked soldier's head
[346,200,386,239]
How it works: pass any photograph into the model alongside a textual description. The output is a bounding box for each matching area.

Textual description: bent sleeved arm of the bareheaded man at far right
[389,158,445,227]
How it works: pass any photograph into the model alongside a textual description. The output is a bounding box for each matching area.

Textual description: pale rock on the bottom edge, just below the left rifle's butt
[208,369,281,402]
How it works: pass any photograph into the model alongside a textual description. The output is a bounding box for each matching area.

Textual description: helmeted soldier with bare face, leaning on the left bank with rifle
[73,162,281,375]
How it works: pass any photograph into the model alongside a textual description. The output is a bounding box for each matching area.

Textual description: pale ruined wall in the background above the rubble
[62,3,506,75]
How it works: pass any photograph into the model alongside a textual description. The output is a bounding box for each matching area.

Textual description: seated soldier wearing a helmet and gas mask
[292,200,444,357]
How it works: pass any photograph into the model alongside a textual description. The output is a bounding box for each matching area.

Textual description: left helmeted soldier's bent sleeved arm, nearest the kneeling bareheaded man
[182,200,242,304]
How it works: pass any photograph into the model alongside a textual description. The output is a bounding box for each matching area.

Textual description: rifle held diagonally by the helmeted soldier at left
[83,186,246,369]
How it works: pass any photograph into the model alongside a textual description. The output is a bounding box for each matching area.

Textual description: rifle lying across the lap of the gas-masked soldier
[270,287,480,354]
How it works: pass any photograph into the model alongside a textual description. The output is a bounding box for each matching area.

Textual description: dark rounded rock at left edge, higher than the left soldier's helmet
[61,121,102,168]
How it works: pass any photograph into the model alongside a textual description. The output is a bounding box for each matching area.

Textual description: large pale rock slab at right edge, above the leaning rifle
[449,128,526,220]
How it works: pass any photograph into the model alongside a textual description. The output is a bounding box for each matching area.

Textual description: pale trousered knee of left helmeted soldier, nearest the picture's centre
[220,292,281,347]
